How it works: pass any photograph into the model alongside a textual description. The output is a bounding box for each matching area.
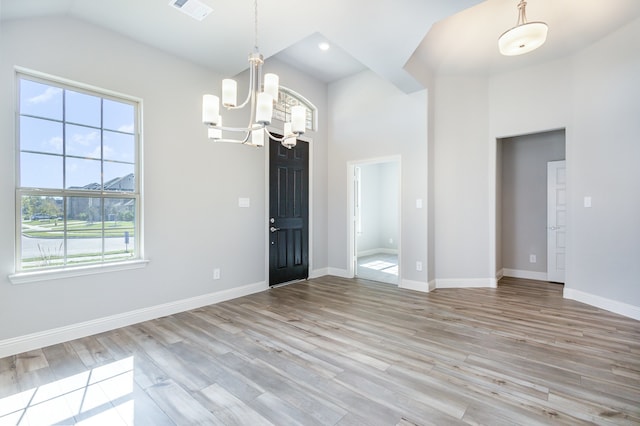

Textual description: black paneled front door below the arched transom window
[269,140,309,286]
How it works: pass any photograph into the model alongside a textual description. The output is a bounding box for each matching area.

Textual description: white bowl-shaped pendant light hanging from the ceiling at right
[498,0,548,56]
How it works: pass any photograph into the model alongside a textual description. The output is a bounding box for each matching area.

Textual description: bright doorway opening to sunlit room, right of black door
[348,157,400,285]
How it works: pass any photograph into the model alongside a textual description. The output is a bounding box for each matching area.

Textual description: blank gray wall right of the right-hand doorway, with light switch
[565,19,640,302]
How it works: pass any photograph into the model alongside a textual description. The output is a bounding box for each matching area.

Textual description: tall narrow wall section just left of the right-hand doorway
[433,76,488,286]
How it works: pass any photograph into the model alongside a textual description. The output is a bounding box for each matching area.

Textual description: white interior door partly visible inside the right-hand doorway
[547,161,567,283]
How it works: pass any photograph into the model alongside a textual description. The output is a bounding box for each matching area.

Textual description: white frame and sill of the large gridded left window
[9,67,147,284]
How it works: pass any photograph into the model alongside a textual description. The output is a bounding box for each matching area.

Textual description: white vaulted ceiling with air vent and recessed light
[0,0,640,92]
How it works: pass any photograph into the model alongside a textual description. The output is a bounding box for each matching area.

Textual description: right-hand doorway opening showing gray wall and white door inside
[496,129,566,282]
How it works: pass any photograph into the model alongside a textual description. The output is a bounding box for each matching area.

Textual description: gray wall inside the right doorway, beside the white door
[498,130,565,273]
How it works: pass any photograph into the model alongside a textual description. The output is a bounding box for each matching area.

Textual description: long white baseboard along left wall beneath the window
[0,282,269,358]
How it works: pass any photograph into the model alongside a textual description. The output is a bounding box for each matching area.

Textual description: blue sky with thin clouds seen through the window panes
[20,78,136,189]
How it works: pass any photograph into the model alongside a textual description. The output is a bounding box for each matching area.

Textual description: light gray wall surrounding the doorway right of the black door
[328,71,428,287]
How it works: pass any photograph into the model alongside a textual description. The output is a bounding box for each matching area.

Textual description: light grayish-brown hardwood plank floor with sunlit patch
[0,277,640,426]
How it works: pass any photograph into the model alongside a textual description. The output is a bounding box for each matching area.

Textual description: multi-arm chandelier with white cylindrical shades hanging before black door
[202,0,306,149]
